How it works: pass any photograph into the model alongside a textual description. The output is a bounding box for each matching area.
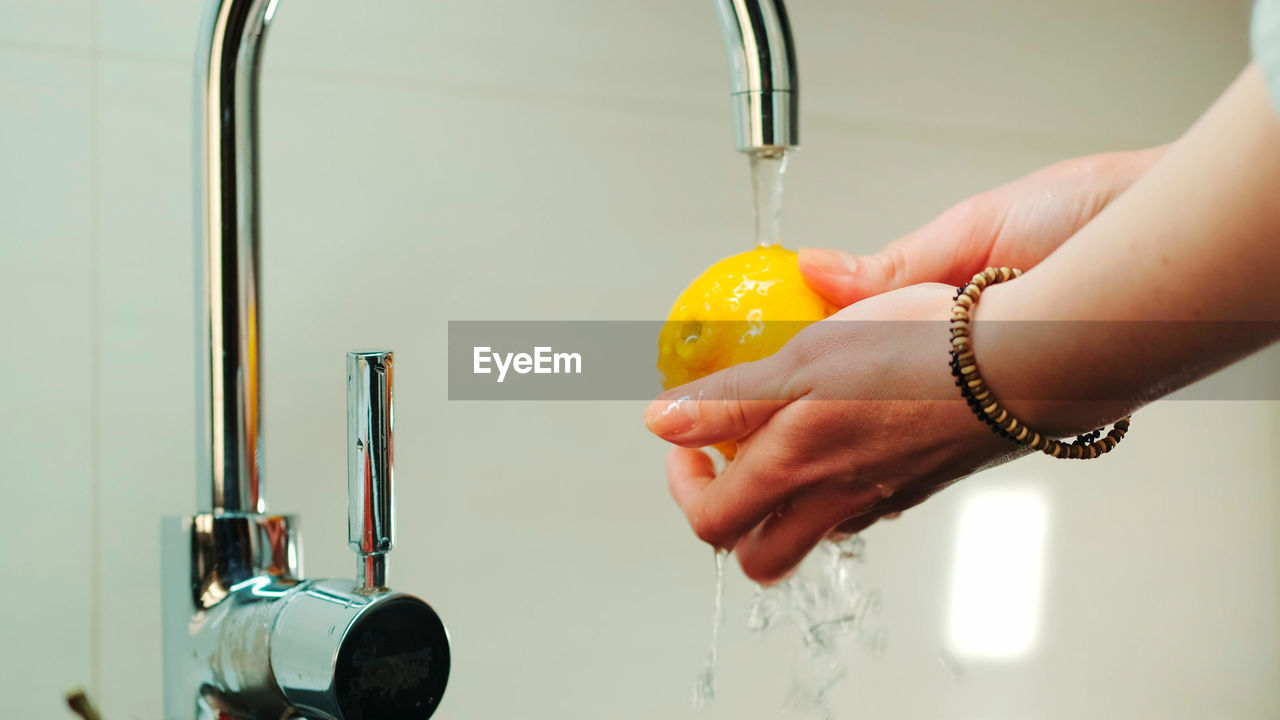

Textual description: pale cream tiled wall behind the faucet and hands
[0,0,1280,720]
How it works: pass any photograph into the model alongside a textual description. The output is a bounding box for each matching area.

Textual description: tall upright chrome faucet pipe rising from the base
[195,0,276,514]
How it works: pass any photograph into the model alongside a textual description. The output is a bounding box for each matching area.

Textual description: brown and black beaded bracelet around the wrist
[951,268,1129,460]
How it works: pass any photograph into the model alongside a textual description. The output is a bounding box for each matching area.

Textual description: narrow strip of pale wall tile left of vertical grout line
[0,44,99,716]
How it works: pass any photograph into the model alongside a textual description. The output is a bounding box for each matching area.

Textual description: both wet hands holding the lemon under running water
[644,147,1164,583]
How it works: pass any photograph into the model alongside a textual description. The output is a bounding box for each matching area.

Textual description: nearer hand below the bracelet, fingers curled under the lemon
[645,284,1019,582]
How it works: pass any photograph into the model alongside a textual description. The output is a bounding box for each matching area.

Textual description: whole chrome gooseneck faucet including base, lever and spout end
[163,0,797,720]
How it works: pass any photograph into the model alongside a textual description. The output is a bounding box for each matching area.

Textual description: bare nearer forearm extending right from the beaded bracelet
[974,67,1280,433]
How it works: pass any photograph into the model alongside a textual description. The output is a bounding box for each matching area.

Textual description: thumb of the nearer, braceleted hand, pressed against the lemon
[644,348,804,447]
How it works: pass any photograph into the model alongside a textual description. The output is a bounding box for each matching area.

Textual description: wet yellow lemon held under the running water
[658,245,838,459]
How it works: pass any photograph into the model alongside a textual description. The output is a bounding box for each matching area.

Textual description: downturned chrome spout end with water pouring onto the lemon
[714,0,800,155]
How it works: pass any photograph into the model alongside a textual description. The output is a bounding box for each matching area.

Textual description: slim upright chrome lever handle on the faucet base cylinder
[347,350,396,593]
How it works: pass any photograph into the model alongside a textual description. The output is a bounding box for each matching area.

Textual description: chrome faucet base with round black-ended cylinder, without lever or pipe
[161,514,452,720]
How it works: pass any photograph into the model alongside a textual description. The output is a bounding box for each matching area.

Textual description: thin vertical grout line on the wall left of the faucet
[88,0,102,703]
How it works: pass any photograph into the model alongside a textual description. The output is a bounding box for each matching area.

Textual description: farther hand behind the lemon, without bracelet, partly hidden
[800,146,1167,307]
